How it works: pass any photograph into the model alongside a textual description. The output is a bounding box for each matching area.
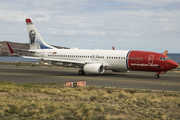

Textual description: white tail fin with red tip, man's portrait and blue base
[26,18,57,50]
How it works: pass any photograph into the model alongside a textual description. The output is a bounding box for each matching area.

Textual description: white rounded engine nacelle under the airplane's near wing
[83,63,104,74]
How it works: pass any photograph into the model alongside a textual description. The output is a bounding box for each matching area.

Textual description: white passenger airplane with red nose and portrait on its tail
[9,18,178,78]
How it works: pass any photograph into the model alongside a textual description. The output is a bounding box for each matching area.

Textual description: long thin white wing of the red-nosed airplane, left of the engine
[23,56,85,65]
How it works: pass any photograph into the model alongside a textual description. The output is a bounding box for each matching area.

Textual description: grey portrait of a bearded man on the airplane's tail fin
[29,30,41,49]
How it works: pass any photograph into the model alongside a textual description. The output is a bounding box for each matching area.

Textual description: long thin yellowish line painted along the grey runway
[0,73,180,85]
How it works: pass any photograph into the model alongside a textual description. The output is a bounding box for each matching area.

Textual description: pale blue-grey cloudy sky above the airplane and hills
[0,0,180,53]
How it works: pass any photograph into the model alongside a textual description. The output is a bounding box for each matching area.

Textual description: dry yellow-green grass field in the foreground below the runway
[0,81,180,120]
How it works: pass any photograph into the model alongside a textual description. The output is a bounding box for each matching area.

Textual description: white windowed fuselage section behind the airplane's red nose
[34,49,129,70]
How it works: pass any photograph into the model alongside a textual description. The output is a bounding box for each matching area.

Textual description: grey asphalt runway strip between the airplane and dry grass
[0,65,180,91]
